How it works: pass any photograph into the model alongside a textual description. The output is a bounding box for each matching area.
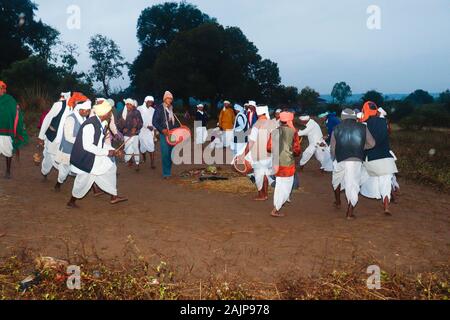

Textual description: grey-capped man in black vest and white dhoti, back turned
[330,109,375,219]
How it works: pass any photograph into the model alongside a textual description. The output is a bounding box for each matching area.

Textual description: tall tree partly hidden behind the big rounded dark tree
[129,2,215,95]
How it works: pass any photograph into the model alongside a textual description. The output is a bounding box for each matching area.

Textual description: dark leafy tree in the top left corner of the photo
[0,0,59,72]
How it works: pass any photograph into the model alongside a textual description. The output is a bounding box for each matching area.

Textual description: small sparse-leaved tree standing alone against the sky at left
[88,34,128,97]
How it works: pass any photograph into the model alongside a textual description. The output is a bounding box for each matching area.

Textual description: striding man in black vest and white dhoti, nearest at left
[67,101,127,208]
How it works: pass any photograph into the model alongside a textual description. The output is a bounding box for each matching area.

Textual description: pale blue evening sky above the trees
[34,0,450,94]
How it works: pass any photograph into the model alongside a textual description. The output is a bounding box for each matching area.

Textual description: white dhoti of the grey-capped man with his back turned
[333,161,362,207]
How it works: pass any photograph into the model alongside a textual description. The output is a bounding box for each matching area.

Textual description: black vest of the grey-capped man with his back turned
[333,119,366,162]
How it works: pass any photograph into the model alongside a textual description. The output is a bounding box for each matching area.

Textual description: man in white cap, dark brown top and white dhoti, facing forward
[118,99,143,171]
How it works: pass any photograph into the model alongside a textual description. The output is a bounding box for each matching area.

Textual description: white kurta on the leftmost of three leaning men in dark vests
[39,101,71,176]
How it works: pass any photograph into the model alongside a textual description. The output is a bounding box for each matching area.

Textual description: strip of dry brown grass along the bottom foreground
[0,243,450,300]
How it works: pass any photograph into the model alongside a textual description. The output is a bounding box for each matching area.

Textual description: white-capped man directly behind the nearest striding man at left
[55,100,92,192]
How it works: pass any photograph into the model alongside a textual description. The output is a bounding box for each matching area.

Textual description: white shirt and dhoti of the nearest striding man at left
[71,120,117,199]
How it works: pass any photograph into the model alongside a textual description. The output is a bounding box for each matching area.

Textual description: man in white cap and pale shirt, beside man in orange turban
[239,106,276,201]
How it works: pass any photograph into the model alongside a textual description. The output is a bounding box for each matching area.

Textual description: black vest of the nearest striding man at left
[70,117,105,173]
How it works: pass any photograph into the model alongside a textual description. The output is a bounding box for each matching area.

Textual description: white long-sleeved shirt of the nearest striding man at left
[72,116,115,176]
